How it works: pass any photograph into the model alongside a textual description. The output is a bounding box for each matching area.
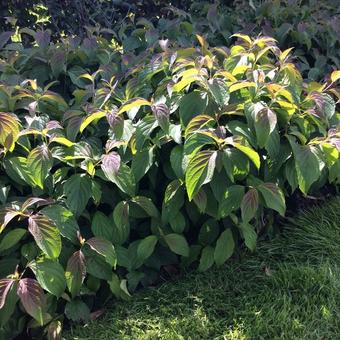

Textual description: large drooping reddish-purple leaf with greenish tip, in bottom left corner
[17,278,46,325]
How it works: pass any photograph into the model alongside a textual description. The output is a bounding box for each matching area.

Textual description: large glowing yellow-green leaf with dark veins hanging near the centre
[185,150,217,201]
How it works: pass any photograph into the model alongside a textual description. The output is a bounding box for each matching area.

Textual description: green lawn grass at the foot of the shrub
[64,198,340,340]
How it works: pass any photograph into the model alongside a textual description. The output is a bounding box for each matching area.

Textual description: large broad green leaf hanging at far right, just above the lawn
[288,136,321,195]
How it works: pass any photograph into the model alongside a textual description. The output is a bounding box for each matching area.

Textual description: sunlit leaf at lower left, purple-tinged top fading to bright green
[28,215,61,258]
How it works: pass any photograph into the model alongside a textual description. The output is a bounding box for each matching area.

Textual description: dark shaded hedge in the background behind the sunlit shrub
[0,0,340,80]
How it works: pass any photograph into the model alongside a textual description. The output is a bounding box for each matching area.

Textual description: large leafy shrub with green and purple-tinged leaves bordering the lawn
[0,31,340,338]
